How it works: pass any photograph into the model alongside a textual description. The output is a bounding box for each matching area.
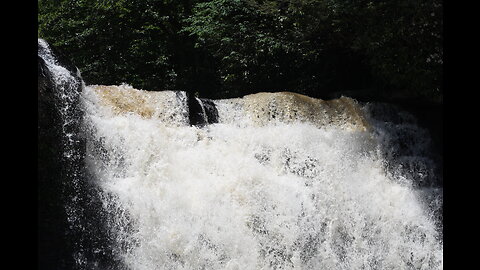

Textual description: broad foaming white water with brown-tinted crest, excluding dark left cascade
[82,85,443,270]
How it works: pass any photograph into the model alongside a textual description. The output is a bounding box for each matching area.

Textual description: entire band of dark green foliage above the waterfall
[39,0,443,100]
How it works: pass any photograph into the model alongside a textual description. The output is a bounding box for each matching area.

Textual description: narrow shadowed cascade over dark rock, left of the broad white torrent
[38,39,123,269]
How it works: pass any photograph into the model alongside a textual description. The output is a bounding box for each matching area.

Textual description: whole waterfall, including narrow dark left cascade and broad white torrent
[38,39,443,270]
